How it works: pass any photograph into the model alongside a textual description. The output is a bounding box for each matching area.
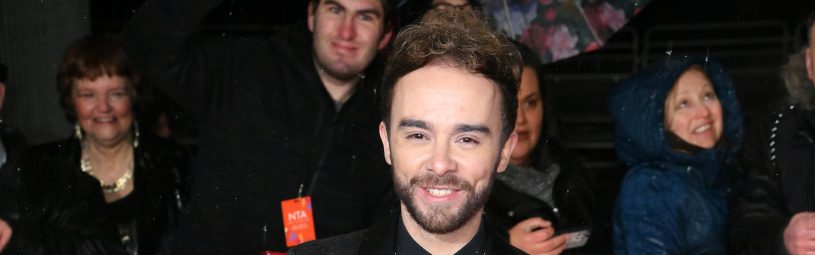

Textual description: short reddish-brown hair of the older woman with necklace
[57,35,142,122]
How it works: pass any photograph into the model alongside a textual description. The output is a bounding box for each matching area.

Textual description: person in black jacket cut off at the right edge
[730,9,815,254]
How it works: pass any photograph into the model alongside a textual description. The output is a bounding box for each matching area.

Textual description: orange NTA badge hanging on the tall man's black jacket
[280,196,316,247]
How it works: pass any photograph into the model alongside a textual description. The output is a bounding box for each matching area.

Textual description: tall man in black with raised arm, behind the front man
[123,0,395,254]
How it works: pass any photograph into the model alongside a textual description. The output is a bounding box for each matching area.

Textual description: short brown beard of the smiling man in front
[393,168,495,234]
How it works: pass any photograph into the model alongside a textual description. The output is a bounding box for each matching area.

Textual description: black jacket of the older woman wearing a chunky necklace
[4,135,189,254]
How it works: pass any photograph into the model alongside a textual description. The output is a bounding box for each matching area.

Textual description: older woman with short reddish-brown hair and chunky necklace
[2,36,186,254]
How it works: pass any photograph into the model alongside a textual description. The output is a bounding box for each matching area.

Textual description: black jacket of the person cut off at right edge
[730,102,815,254]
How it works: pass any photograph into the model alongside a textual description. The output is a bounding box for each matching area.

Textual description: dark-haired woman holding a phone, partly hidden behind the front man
[487,44,609,254]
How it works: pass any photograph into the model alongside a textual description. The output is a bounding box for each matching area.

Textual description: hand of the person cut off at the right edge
[784,212,815,255]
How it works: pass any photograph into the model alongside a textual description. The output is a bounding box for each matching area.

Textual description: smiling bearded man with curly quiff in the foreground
[289,9,523,255]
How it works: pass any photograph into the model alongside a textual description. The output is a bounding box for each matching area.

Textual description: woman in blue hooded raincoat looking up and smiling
[609,57,743,254]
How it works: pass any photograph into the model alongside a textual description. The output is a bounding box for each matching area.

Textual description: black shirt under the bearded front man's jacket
[396,214,487,255]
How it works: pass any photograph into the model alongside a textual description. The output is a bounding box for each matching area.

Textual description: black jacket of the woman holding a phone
[485,140,611,254]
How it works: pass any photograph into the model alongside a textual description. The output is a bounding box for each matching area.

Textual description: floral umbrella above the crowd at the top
[479,0,651,63]
